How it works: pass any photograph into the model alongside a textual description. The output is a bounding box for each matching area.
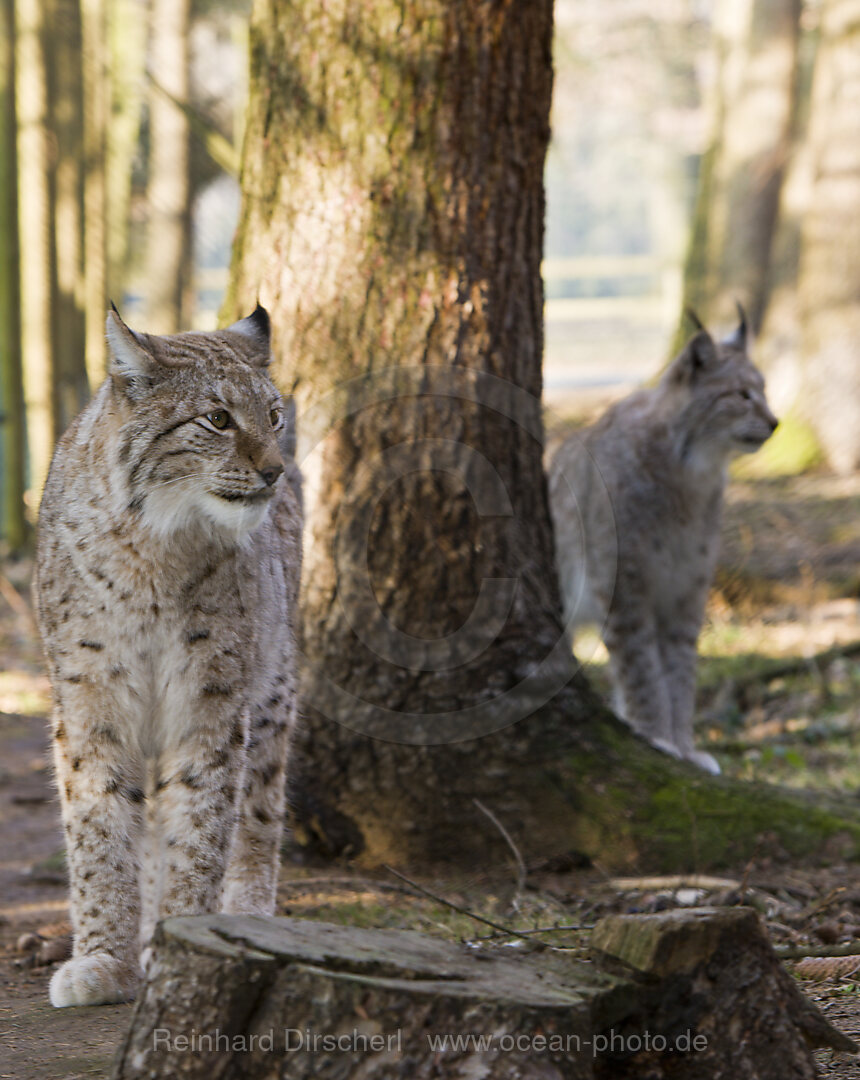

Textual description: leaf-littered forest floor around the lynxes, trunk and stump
[0,472,860,1080]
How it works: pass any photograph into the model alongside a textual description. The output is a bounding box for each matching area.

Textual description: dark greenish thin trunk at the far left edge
[0,0,27,551]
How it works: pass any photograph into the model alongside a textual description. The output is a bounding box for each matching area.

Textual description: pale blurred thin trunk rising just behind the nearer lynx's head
[147,0,191,334]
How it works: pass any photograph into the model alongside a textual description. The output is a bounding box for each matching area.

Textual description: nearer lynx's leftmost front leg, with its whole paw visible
[51,692,144,1008]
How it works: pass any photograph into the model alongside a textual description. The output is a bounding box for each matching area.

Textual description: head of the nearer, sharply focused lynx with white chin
[107,306,292,539]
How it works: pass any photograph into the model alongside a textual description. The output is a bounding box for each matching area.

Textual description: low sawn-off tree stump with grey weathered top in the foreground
[115,909,855,1080]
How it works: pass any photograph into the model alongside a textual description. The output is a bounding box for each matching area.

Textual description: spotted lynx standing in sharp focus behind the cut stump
[33,307,301,1007]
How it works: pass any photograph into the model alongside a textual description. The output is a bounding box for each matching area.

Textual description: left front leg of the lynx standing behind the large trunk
[604,615,680,757]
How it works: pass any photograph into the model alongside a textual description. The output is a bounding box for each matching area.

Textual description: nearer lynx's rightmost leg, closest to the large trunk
[223,686,292,915]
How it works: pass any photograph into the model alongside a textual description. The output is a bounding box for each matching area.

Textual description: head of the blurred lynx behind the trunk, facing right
[660,305,778,458]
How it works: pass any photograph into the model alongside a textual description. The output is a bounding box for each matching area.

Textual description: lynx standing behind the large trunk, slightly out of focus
[550,312,777,773]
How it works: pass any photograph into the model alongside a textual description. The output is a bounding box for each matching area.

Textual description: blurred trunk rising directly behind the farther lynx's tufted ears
[675,0,801,345]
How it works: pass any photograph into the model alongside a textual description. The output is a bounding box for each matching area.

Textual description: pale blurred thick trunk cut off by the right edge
[798,0,860,472]
